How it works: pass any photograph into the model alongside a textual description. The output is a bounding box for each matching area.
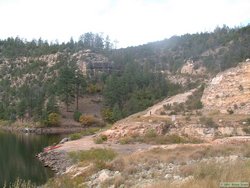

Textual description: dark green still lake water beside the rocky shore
[0,131,60,187]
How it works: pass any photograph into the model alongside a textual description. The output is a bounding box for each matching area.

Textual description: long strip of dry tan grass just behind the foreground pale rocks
[109,144,250,176]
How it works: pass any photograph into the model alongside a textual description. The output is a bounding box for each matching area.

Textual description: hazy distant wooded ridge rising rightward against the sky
[111,25,250,73]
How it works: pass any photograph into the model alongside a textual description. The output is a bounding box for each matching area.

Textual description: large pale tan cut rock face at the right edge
[201,61,250,114]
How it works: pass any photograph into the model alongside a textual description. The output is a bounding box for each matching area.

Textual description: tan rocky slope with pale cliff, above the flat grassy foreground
[102,60,250,143]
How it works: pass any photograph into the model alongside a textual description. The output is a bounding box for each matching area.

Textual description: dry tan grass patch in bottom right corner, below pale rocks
[147,160,250,188]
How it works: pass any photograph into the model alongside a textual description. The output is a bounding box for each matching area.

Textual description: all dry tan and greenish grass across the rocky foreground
[47,143,250,188]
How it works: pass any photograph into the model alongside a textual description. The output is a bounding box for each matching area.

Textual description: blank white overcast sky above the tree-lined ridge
[0,0,250,47]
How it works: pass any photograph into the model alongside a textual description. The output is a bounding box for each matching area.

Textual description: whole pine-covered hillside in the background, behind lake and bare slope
[0,26,250,124]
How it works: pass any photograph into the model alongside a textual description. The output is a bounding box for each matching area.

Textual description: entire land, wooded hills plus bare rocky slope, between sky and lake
[0,26,250,188]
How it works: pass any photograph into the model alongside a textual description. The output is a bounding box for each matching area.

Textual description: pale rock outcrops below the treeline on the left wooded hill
[0,50,113,81]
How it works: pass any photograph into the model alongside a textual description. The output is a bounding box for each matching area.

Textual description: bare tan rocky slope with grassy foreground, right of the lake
[39,61,250,188]
